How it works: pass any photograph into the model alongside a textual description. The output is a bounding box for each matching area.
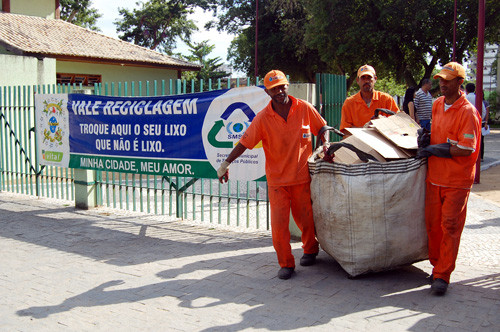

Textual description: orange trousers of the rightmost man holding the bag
[425,183,470,283]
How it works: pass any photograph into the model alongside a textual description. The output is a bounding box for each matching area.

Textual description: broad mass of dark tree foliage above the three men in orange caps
[204,0,500,86]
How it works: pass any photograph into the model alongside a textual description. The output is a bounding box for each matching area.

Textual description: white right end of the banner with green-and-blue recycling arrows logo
[202,86,270,180]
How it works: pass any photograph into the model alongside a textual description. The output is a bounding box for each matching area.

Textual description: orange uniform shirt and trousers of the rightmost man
[425,94,481,283]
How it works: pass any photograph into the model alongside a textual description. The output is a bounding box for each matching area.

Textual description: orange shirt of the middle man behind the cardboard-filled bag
[340,91,399,130]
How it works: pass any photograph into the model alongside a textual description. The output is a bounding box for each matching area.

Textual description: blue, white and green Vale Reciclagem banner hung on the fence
[35,87,270,180]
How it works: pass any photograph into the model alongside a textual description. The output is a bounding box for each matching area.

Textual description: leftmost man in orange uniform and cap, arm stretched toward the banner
[217,70,326,279]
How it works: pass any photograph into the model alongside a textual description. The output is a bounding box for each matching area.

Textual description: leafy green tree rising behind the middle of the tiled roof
[115,0,198,54]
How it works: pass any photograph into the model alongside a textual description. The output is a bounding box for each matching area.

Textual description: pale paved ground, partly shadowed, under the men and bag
[0,129,500,332]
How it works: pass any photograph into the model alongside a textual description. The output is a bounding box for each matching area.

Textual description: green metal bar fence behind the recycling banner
[0,74,345,230]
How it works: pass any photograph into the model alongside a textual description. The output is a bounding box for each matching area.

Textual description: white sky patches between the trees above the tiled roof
[92,0,233,63]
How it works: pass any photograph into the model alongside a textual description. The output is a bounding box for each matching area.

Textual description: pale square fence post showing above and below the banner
[72,89,98,210]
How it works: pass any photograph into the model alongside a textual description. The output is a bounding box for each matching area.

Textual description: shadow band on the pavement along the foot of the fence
[0,196,272,266]
